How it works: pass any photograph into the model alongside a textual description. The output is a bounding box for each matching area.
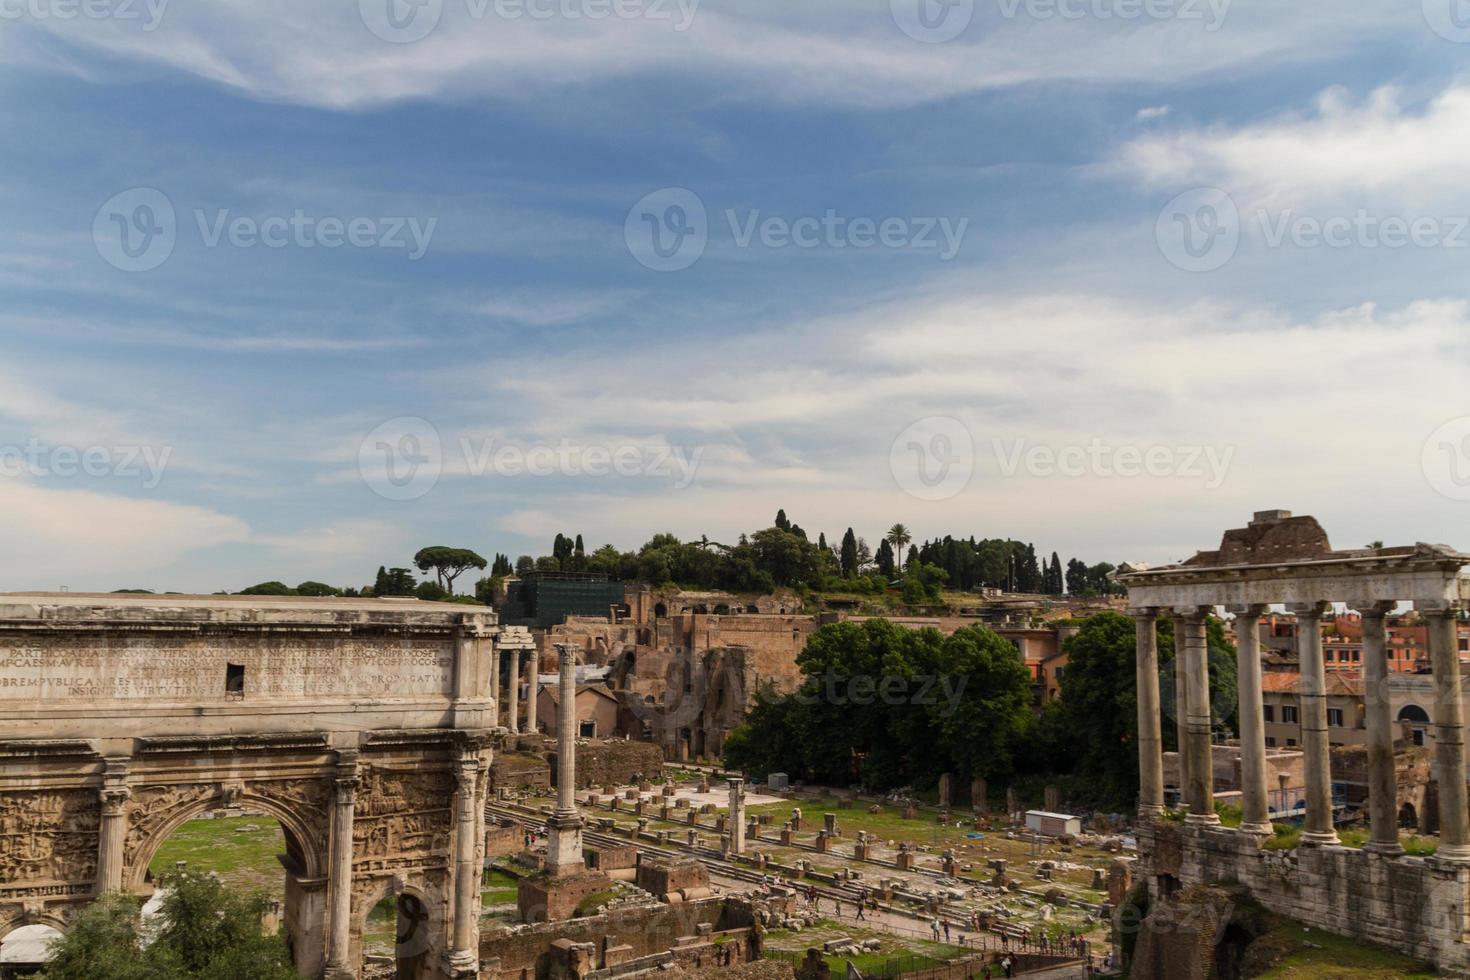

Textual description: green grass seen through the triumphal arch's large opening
[148,814,285,898]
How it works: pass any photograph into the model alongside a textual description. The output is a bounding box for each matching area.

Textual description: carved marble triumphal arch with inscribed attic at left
[0,594,498,980]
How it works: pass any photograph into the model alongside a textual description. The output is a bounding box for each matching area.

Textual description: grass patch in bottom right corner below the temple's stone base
[1244,921,1439,980]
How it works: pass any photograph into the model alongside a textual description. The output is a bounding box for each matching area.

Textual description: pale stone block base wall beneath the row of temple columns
[1138,823,1470,971]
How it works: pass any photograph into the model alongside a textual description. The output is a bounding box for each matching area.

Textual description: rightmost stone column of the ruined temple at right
[1414,602,1470,864]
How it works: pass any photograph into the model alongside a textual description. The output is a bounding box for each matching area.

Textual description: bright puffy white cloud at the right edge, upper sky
[1114,85,1470,206]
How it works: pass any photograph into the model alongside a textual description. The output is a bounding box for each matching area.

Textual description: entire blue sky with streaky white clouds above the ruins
[0,0,1470,591]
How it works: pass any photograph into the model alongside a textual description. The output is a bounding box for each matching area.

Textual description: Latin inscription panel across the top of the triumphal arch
[0,635,454,704]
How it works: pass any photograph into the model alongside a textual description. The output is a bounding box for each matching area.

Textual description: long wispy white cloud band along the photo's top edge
[7,0,1426,109]
